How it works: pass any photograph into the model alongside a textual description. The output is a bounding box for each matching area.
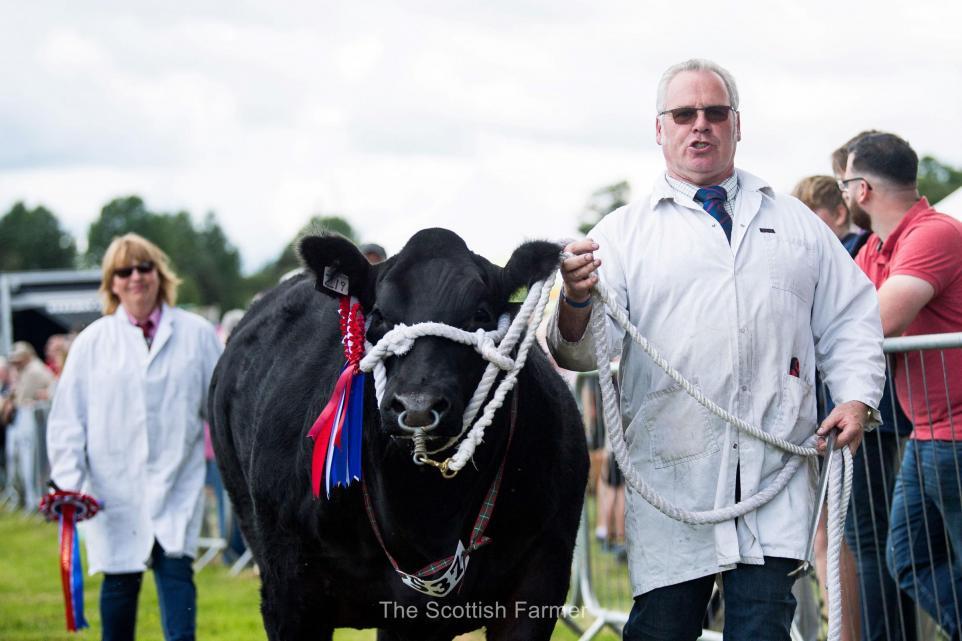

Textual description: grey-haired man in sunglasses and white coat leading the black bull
[548,60,884,641]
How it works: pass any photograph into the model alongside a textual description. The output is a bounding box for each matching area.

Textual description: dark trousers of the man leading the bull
[622,556,799,641]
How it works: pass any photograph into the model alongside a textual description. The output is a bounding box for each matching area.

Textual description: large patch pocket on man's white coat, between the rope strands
[638,378,719,468]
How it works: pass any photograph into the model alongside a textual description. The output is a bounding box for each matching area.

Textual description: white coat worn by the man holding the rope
[548,171,885,596]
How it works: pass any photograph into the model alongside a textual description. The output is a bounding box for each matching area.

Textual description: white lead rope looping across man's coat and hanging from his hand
[589,283,852,641]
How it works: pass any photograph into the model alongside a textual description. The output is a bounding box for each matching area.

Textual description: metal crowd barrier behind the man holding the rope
[566,333,962,641]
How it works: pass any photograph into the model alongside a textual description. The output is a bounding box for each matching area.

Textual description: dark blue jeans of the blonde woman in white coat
[100,541,197,641]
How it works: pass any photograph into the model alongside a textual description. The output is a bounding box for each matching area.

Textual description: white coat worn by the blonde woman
[47,305,221,574]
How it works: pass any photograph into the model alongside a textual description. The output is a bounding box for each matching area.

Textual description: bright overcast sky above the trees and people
[0,0,962,271]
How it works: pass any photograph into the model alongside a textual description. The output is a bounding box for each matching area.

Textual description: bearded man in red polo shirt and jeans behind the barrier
[839,133,962,639]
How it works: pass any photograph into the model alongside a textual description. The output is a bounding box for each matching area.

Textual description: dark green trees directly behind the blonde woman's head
[86,196,249,309]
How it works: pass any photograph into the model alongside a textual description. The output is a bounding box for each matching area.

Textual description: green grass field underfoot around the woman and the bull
[0,511,618,641]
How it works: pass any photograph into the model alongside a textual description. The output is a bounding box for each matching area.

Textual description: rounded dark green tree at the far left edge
[0,202,77,271]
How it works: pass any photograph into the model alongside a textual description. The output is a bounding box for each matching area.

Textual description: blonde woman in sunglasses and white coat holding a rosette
[47,234,221,641]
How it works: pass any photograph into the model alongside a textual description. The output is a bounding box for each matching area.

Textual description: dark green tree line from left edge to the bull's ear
[0,196,357,309]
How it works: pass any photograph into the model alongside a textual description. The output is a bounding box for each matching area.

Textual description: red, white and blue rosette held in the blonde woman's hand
[40,489,101,632]
